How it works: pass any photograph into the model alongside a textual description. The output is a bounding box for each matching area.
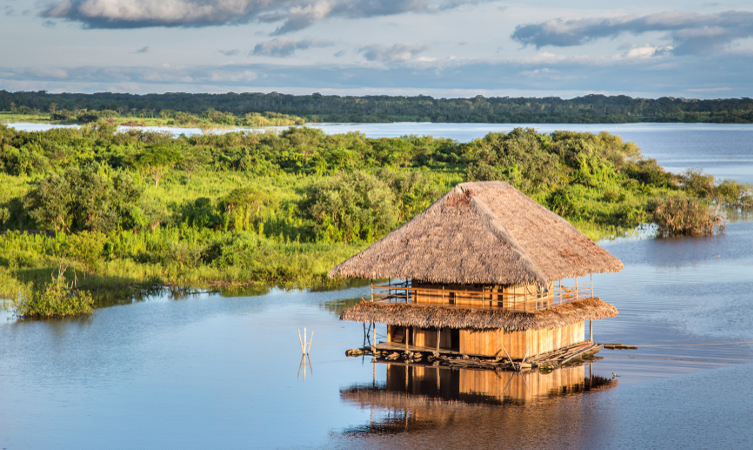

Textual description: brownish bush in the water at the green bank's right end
[648,195,724,236]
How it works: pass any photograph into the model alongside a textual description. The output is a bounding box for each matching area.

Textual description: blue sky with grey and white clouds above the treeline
[0,0,753,98]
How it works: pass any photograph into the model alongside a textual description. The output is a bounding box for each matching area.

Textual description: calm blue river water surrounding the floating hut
[0,124,753,449]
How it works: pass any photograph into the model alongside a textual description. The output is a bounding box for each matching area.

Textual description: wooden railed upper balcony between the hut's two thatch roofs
[371,278,593,311]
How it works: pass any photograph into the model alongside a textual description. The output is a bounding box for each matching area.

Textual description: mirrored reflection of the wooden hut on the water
[340,363,617,434]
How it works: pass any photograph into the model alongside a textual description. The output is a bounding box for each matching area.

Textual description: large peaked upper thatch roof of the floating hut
[329,181,623,285]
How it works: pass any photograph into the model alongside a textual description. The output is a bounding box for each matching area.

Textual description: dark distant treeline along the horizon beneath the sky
[0,90,753,123]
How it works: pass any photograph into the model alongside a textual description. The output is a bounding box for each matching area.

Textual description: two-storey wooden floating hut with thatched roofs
[330,181,623,359]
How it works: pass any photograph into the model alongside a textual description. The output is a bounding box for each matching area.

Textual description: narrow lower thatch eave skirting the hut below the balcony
[340,297,617,331]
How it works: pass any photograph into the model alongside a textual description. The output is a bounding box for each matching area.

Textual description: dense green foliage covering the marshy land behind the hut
[0,121,753,311]
